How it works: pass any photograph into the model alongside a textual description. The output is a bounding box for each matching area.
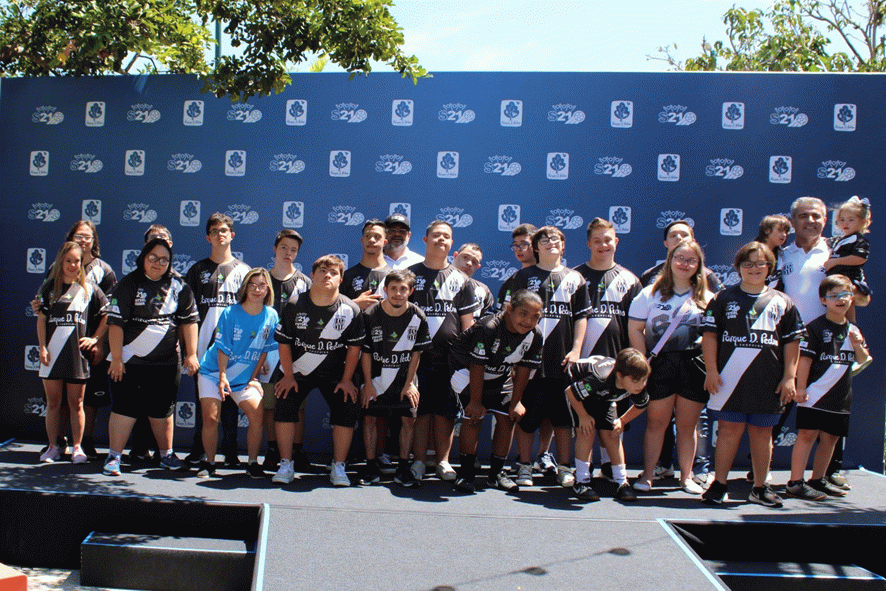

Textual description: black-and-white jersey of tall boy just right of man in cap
[409,263,479,366]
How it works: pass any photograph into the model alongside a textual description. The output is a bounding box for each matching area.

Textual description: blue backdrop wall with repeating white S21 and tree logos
[0,73,886,470]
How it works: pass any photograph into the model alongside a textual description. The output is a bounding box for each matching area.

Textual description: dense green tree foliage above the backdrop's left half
[0,0,428,101]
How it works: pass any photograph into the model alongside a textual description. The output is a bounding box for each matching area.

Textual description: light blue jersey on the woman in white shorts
[200,304,278,392]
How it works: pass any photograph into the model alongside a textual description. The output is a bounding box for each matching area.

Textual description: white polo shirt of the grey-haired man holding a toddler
[778,238,831,324]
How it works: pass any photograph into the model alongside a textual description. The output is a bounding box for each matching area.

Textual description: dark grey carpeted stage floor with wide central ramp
[0,442,886,591]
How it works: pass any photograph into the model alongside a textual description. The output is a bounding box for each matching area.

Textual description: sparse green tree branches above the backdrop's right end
[649,0,886,72]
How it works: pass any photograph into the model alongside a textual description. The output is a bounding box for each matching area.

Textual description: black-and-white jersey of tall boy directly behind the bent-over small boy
[575,263,642,358]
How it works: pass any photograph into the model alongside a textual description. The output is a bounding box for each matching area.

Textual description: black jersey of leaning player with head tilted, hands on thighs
[449,313,544,393]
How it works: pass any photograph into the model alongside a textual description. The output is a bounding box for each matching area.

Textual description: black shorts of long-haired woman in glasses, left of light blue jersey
[111,364,180,419]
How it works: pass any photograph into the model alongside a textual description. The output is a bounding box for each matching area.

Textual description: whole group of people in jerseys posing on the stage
[32,197,871,507]
